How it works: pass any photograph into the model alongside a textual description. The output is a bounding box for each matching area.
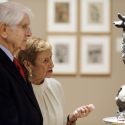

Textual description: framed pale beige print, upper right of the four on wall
[80,0,111,33]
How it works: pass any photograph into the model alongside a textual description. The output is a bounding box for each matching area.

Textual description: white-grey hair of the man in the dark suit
[0,2,33,26]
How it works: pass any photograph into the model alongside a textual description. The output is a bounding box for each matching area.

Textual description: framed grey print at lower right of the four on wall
[80,35,110,75]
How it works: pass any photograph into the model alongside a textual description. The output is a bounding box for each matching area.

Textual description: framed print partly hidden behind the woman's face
[47,35,77,75]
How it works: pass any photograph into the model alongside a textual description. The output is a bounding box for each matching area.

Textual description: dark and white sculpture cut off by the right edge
[113,13,125,121]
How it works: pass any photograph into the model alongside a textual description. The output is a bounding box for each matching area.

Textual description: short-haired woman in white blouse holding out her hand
[18,37,93,125]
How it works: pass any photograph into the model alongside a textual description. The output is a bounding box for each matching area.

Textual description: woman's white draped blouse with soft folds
[32,78,66,125]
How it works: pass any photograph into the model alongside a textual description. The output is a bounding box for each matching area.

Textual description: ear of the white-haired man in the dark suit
[0,23,7,39]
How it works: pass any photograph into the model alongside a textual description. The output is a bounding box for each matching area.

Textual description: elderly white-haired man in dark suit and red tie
[0,2,43,125]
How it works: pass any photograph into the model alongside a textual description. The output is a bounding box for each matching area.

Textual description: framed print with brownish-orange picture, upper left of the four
[47,0,77,32]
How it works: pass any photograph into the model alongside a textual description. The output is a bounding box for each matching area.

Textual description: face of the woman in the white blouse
[31,50,54,83]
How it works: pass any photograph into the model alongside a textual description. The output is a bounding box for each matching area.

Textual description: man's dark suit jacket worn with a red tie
[0,49,43,125]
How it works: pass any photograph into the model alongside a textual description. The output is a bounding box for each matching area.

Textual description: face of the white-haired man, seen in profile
[6,15,32,52]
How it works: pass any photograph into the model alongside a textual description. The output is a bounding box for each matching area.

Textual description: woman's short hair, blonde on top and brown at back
[18,37,52,65]
